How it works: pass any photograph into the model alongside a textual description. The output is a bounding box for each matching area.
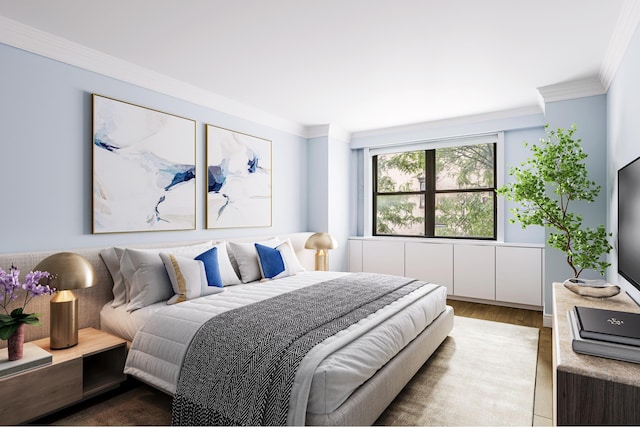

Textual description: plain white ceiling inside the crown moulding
[0,0,636,132]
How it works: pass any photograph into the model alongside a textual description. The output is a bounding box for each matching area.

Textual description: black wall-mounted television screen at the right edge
[618,157,640,290]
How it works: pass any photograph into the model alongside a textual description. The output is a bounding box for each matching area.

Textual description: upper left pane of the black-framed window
[378,151,424,193]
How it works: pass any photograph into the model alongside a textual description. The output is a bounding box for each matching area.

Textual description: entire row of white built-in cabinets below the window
[349,238,544,307]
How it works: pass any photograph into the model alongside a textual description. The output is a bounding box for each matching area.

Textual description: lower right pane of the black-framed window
[435,191,495,238]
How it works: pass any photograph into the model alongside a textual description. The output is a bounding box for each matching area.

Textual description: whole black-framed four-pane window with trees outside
[372,142,496,239]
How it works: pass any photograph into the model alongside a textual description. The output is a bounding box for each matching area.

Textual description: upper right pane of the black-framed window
[436,144,495,190]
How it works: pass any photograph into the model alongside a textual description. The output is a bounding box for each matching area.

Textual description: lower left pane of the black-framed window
[376,194,424,236]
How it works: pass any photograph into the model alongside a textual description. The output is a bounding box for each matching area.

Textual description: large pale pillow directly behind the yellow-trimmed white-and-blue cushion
[120,242,211,311]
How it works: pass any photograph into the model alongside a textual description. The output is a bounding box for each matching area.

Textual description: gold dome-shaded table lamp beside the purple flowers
[36,252,96,349]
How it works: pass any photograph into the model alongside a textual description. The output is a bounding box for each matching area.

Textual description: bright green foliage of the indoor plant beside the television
[497,125,612,278]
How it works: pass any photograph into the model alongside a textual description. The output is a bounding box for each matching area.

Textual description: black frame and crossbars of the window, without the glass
[371,142,498,241]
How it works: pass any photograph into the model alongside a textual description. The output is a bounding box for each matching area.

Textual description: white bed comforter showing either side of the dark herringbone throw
[125,272,446,425]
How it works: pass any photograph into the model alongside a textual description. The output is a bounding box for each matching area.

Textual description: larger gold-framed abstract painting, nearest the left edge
[93,94,196,234]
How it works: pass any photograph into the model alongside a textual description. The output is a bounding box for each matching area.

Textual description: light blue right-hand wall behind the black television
[606,22,640,301]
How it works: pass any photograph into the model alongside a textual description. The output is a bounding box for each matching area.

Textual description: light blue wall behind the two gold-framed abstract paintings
[0,44,308,253]
